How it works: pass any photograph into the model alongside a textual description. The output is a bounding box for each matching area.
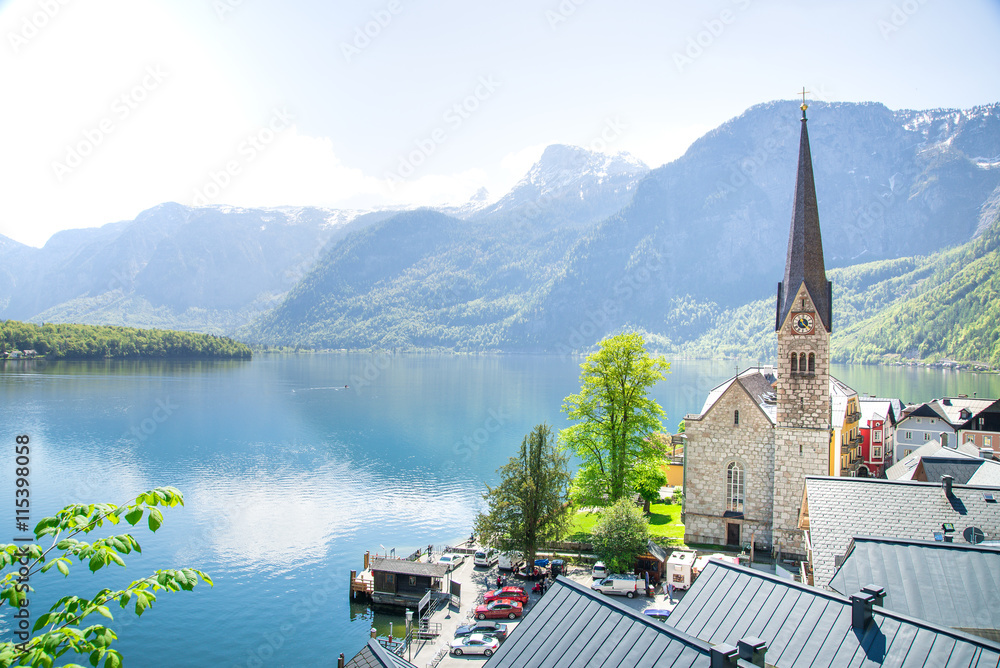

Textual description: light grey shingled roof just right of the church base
[804,476,1000,587]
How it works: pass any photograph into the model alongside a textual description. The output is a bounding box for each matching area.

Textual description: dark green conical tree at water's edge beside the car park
[475,424,570,564]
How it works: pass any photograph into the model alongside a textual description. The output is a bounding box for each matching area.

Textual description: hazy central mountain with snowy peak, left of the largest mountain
[246,146,648,350]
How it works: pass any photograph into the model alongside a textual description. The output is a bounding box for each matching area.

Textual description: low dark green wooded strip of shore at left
[0,320,252,360]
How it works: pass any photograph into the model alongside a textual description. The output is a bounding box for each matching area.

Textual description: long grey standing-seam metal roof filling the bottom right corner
[667,560,1000,668]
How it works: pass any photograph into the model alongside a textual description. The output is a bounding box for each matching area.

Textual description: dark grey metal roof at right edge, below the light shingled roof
[830,536,1000,641]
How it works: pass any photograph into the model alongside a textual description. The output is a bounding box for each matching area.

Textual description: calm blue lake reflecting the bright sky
[0,354,1000,668]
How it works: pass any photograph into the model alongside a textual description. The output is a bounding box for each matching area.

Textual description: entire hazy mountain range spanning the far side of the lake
[7,101,1000,360]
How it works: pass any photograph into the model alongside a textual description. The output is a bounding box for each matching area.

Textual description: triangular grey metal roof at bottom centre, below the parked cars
[486,576,711,668]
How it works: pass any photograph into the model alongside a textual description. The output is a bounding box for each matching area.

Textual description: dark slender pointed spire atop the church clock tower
[774,100,833,332]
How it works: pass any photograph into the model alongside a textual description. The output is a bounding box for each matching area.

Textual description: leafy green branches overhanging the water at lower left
[0,487,212,668]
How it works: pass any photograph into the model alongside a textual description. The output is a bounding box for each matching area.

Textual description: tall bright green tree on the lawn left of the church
[560,333,670,506]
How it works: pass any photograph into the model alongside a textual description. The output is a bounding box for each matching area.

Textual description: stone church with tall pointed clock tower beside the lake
[683,102,860,557]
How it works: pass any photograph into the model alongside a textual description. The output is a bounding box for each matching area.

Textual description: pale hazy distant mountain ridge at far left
[0,203,366,333]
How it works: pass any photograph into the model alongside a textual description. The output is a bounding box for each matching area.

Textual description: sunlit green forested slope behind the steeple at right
[672,219,1000,367]
